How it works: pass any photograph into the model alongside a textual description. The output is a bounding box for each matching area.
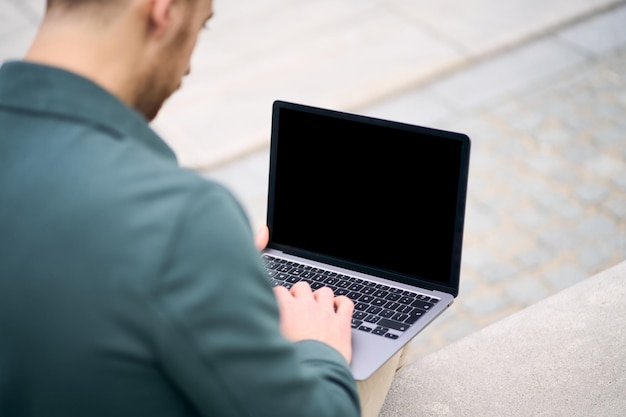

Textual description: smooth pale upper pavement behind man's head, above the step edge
[0,0,621,169]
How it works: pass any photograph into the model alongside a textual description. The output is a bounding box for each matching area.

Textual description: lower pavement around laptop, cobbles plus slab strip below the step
[207,7,626,355]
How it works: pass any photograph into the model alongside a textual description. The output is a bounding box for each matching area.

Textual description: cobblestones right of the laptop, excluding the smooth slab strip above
[402,49,626,352]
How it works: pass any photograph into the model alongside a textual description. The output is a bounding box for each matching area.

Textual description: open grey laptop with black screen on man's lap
[263,101,470,380]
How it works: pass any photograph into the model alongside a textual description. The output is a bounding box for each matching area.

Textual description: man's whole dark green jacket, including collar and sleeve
[0,62,358,417]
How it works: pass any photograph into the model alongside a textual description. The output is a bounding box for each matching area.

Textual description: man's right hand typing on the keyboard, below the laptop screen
[274,282,354,363]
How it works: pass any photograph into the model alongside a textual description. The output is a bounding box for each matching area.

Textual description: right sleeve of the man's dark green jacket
[149,181,359,417]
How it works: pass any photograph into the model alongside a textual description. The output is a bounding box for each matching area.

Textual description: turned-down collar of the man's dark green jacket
[0,61,176,160]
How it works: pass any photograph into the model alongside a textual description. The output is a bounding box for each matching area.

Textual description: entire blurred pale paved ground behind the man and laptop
[0,0,626,354]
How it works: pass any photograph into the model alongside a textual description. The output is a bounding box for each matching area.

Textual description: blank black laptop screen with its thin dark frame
[268,102,469,295]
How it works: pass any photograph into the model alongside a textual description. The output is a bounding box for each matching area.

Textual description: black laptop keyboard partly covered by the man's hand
[263,254,439,339]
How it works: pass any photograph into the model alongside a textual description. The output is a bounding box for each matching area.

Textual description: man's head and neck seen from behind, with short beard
[26,0,213,120]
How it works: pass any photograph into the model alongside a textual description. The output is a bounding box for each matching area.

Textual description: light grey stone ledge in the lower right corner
[380,262,626,417]
